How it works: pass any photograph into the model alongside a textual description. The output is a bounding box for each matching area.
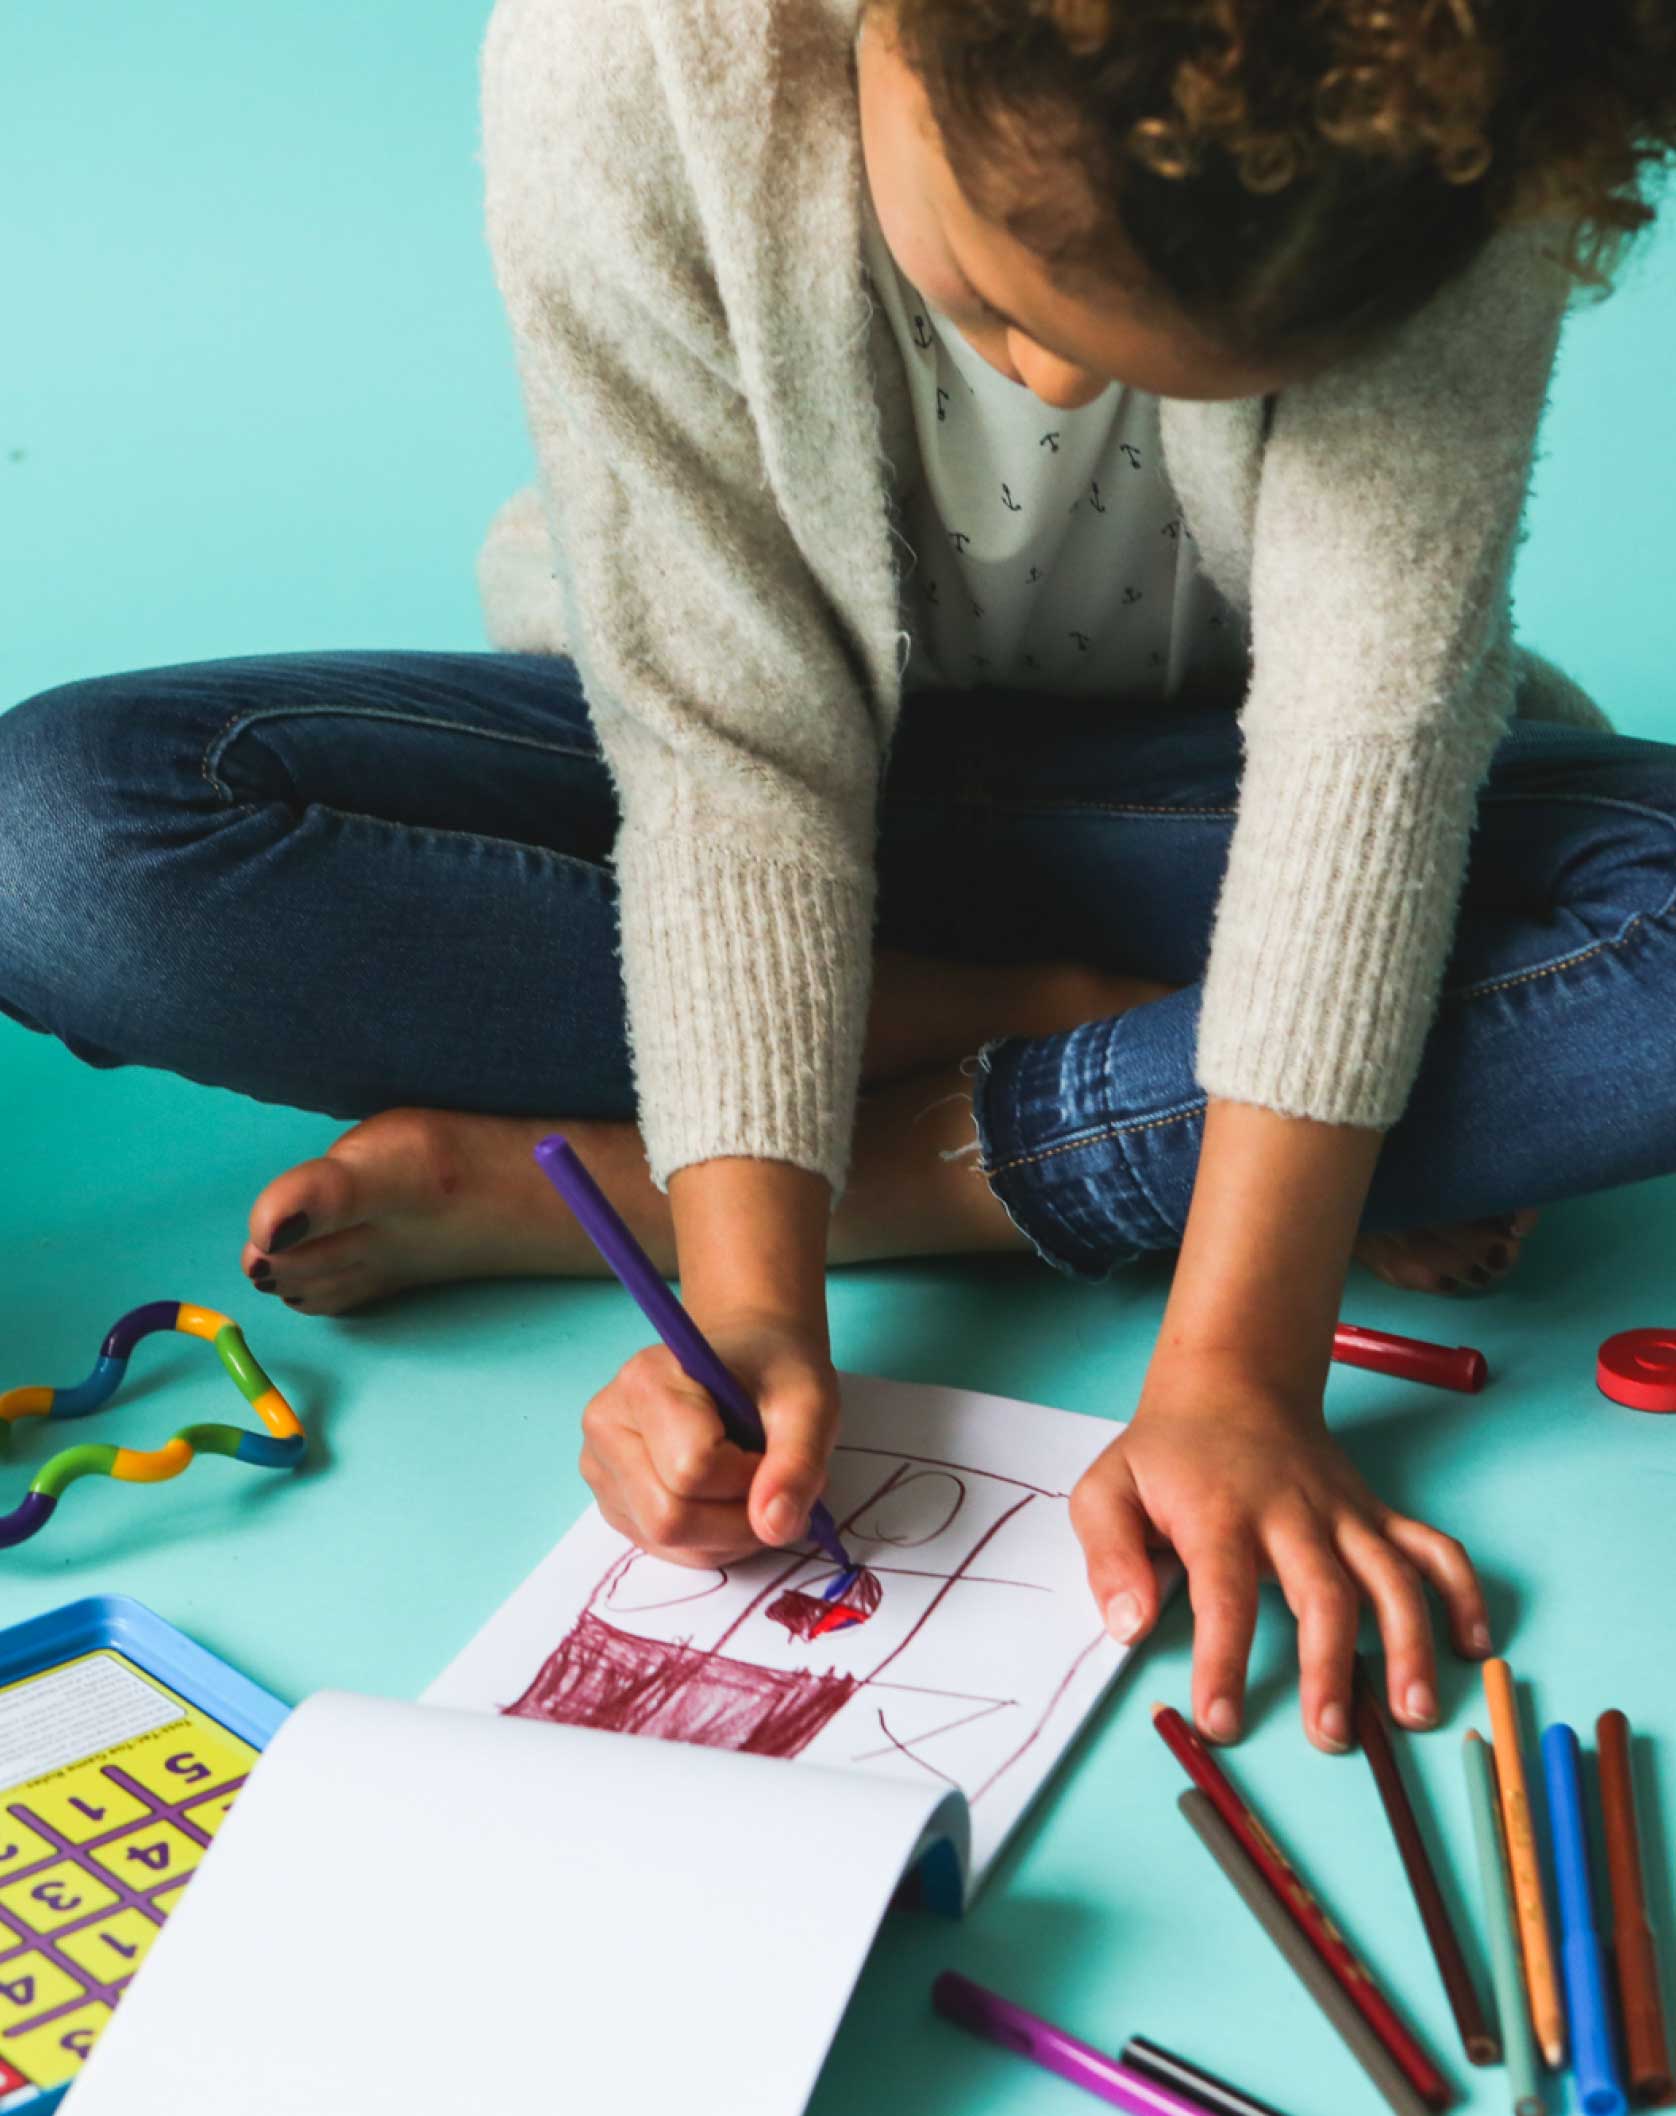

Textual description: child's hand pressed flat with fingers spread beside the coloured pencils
[1071,1358,1490,1750]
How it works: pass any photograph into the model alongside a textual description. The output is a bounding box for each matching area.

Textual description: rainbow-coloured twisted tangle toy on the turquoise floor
[0,1301,309,1549]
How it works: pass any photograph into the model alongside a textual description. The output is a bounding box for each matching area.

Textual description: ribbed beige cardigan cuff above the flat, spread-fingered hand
[1196,728,1494,1130]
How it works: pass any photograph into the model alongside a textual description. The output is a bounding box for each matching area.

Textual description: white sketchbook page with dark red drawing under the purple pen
[425,1373,1128,1890]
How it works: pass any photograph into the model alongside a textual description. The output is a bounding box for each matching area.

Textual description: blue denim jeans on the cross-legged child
[0,652,1676,1278]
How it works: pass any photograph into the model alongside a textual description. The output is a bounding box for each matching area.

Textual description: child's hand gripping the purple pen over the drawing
[582,1318,838,1566]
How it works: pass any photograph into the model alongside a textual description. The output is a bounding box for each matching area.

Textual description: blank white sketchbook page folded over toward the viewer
[74,1691,963,2116]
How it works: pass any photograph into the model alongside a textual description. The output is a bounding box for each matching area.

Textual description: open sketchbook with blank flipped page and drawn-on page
[76,1375,1159,2116]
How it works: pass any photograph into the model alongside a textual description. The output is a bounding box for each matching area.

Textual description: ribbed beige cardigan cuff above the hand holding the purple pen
[616,827,874,1204]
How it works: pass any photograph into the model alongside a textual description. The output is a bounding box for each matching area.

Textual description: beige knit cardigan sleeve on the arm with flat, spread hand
[1198,226,1568,1128]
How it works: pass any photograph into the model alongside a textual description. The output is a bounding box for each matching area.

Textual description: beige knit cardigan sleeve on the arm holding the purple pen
[480,0,885,1198]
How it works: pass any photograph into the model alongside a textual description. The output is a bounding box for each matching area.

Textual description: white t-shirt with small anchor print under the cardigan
[861,182,1246,700]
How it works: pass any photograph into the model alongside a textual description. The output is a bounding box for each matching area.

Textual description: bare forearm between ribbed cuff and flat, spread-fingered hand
[1158,1096,1384,1401]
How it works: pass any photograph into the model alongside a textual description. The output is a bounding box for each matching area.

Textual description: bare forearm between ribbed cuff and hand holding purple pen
[669,1155,832,1348]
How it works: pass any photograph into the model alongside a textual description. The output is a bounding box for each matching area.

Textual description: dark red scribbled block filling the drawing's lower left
[504,1602,857,1756]
